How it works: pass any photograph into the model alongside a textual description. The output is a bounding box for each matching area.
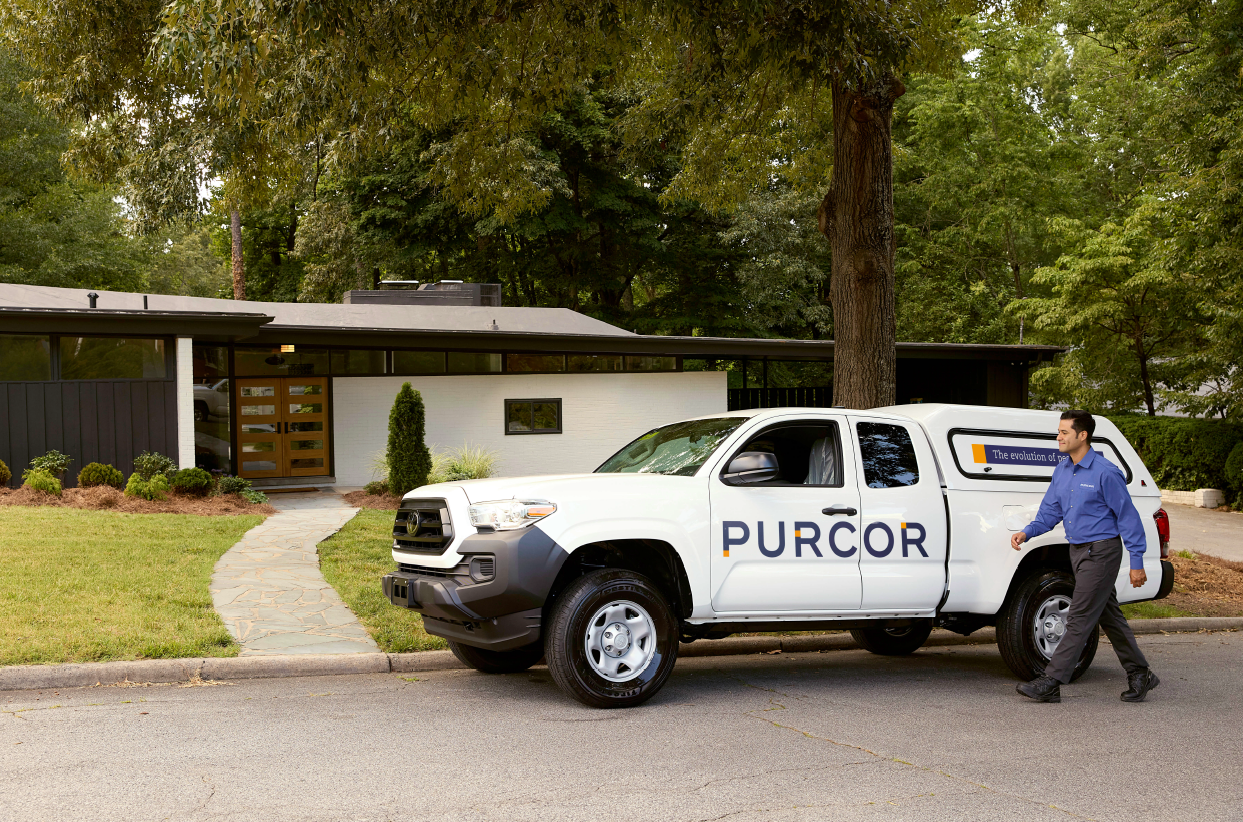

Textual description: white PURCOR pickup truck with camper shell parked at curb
[383,404,1173,708]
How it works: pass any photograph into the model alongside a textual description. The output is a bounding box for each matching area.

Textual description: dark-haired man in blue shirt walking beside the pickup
[1011,410,1160,703]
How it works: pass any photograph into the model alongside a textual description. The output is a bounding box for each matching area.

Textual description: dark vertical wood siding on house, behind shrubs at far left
[0,379,177,487]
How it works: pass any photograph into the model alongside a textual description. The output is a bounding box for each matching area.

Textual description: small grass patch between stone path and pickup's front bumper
[319,509,449,653]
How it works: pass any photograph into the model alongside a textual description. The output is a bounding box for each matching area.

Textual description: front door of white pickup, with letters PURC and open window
[709,415,861,613]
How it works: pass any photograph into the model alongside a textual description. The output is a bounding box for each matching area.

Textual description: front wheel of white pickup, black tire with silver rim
[544,568,679,708]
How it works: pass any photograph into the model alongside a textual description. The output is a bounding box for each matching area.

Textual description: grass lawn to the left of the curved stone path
[0,506,264,665]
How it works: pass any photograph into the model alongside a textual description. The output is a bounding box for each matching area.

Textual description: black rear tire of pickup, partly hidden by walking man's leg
[997,568,1100,681]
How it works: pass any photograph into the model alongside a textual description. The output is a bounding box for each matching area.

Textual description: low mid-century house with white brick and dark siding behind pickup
[0,282,1062,487]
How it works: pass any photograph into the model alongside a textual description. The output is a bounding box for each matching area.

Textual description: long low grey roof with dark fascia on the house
[0,284,1065,363]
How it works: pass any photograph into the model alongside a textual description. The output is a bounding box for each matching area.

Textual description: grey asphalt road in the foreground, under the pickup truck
[0,633,1243,822]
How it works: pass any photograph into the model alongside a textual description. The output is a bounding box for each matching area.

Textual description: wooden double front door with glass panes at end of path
[235,377,331,479]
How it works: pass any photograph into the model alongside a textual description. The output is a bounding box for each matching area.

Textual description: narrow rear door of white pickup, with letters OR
[850,417,948,611]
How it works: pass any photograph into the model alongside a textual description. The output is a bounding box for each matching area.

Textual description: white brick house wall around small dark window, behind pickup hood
[332,372,727,486]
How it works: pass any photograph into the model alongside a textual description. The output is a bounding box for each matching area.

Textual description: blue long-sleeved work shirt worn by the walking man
[1023,449,1149,571]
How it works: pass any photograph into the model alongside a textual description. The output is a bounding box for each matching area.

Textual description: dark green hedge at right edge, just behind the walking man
[1110,415,1243,491]
